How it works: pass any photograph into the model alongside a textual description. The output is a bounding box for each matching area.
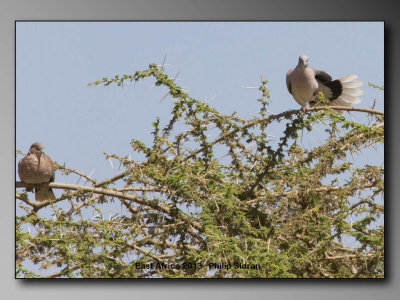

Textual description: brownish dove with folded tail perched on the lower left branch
[18,142,56,201]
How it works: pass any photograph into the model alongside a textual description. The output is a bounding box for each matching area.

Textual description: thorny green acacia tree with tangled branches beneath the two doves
[16,64,384,278]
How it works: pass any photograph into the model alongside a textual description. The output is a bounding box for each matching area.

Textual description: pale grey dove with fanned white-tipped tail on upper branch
[286,55,363,111]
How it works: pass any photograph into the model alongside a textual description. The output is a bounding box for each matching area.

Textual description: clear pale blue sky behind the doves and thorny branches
[16,22,384,276]
